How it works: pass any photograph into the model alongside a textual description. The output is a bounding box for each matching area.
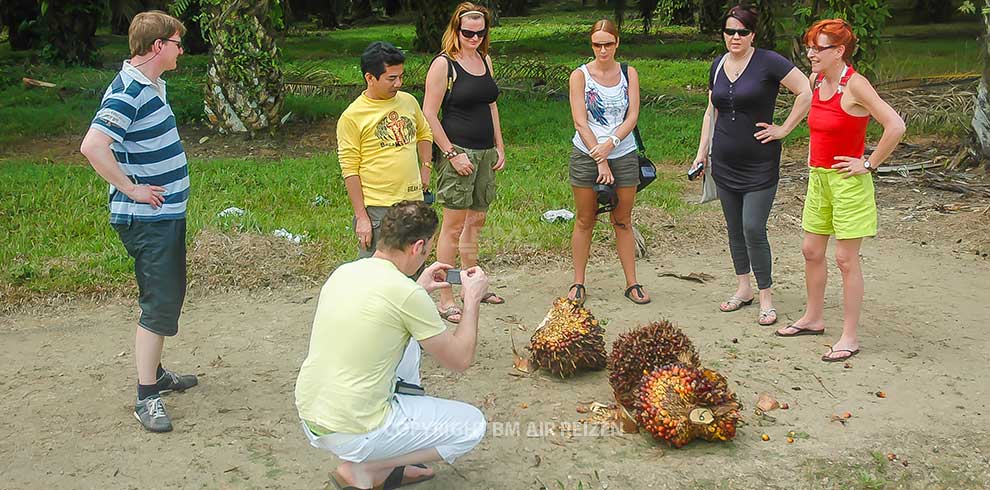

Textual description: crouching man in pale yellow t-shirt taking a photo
[295,201,488,488]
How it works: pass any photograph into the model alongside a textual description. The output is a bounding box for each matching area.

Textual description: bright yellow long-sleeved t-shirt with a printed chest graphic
[337,92,433,206]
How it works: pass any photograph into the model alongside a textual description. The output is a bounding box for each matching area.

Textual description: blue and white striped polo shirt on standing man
[90,61,189,224]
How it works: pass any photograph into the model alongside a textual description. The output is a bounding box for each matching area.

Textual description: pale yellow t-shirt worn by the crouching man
[296,257,446,434]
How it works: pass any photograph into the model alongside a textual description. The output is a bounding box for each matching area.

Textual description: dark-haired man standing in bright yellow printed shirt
[337,41,433,258]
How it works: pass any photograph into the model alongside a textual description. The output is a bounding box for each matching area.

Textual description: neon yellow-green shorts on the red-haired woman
[801,167,877,240]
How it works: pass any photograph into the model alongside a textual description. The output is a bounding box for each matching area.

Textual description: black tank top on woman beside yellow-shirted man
[440,61,498,150]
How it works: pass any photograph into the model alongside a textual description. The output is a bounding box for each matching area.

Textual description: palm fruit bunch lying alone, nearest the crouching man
[529,298,605,378]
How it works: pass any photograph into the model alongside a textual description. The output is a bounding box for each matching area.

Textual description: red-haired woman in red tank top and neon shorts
[777,19,905,362]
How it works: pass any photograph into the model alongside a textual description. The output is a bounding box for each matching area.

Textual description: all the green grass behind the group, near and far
[0,9,979,294]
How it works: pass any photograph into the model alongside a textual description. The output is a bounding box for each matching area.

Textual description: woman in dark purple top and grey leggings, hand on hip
[692,5,811,325]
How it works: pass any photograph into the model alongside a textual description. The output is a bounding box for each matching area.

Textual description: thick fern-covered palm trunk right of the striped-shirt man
[203,0,283,135]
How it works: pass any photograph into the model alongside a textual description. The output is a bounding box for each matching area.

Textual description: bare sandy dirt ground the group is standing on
[0,151,990,490]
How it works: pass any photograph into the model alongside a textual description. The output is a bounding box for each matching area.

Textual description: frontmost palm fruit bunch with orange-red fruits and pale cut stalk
[636,364,742,447]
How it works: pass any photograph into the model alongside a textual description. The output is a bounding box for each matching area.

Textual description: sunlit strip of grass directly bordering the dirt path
[0,95,701,294]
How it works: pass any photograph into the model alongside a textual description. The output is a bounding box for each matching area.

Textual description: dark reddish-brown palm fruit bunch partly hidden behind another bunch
[608,320,699,411]
